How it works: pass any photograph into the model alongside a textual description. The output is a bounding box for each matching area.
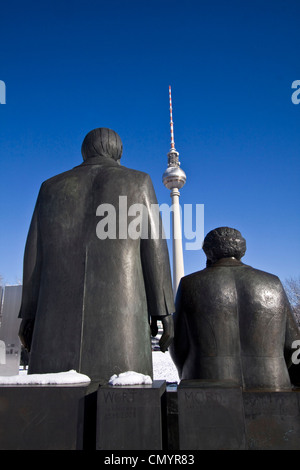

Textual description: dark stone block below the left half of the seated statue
[178,380,246,450]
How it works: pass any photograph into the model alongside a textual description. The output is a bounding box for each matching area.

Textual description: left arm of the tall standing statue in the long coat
[19,190,41,351]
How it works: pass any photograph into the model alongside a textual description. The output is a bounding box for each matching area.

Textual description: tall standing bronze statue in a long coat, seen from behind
[19,128,174,383]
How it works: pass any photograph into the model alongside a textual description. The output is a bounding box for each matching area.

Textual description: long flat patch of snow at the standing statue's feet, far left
[0,370,91,385]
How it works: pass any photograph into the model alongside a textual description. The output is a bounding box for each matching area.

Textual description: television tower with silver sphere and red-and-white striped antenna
[162,86,186,297]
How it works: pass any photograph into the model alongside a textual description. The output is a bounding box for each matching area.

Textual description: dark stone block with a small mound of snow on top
[96,380,166,450]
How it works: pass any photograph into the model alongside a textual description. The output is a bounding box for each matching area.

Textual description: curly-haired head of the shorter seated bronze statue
[203,227,246,266]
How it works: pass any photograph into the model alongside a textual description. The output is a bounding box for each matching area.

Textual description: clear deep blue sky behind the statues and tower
[0,0,300,283]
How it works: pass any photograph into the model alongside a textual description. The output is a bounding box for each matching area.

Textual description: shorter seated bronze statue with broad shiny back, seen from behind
[170,227,300,390]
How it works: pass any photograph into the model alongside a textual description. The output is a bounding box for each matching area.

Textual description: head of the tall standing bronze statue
[81,127,123,163]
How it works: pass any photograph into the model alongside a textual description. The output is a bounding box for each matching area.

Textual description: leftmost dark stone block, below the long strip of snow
[0,384,86,450]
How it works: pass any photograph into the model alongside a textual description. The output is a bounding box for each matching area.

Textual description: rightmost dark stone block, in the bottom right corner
[243,390,300,450]
